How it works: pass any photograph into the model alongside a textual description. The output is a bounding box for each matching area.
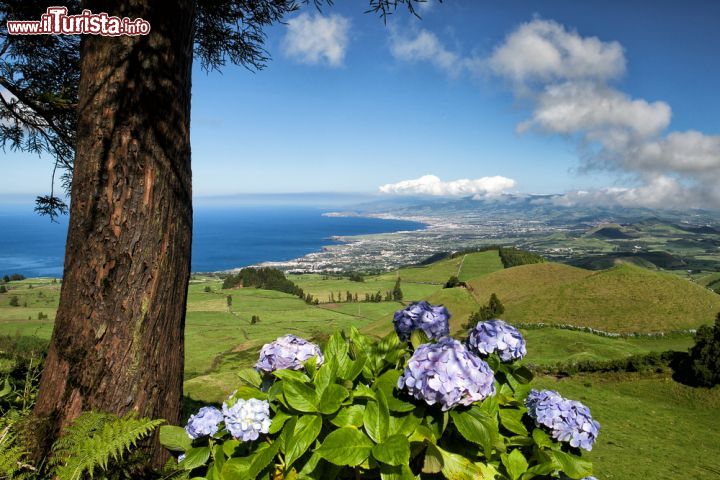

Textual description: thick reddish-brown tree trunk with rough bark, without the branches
[34,0,195,465]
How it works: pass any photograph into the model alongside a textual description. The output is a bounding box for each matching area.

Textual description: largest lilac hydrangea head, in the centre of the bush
[398,337,495,411]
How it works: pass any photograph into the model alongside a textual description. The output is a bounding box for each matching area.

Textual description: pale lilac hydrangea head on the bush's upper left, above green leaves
[255,335,325,373]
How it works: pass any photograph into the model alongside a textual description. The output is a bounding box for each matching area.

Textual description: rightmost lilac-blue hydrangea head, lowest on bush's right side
[525,390,600,451]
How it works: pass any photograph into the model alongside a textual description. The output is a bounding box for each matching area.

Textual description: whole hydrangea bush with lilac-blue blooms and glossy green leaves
[160,302,599,480]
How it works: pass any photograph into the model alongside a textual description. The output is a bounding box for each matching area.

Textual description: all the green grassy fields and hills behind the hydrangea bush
[0,251,720,479]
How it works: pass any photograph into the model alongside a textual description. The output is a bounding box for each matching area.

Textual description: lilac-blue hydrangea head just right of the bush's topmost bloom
[467,319,527,362]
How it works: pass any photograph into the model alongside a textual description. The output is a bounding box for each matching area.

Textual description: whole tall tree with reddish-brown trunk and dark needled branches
[0,0,428,465]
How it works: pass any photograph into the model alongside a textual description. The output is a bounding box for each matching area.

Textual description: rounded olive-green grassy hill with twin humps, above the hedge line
[470,263,720,332]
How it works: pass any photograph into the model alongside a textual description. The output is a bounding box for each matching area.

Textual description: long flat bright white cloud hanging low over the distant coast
[380,175,515,197]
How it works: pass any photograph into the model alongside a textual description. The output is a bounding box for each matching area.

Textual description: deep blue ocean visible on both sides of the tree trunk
[0,206,424,277]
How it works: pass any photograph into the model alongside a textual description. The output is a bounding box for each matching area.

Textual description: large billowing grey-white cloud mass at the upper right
[390,19,720,208]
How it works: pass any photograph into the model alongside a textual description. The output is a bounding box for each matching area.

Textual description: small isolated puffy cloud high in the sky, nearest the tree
[283,13,350,67]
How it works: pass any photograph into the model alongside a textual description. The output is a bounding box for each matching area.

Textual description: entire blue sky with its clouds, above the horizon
[0,0,720,206]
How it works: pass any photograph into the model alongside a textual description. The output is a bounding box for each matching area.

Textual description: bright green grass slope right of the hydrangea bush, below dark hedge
[535,374,720,480]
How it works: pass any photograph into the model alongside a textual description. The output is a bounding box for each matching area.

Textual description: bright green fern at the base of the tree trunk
[53,412,164,480]
